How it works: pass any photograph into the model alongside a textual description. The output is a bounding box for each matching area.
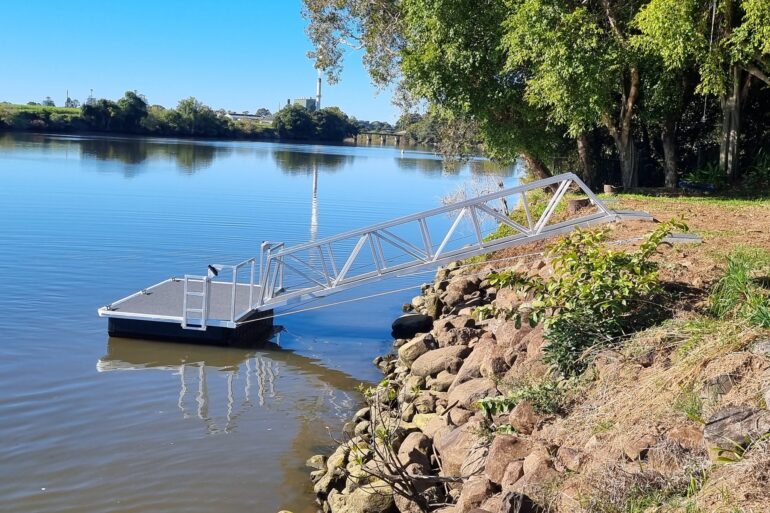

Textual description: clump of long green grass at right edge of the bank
[709,248,770,328]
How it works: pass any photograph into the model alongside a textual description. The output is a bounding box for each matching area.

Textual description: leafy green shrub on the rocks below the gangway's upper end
[515,221,687,376]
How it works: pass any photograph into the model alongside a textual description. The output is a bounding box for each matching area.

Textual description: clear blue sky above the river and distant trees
[0,0,397,121]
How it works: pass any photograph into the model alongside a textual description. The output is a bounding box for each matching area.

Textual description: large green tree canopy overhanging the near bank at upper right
[303,0,770,186]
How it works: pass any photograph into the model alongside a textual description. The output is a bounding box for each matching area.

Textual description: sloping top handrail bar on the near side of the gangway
[270,173,584,258]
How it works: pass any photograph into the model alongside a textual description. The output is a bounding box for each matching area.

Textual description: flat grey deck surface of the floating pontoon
[108,280,259,321]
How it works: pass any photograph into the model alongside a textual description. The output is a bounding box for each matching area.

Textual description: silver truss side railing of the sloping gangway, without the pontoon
[255,173,623,309]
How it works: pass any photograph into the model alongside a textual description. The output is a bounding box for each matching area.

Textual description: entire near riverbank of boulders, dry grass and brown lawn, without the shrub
[300,196,770,513]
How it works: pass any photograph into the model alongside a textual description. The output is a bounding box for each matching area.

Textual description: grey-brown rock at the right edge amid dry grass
[703,407,770,456]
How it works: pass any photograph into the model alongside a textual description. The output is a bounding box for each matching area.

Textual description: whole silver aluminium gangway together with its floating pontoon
[98,173,651,342]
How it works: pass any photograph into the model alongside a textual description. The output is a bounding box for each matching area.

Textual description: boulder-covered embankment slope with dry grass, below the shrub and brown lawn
[308,260,770,513]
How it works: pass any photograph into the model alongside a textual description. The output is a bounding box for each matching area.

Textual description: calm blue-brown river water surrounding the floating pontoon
[0,134,515,513]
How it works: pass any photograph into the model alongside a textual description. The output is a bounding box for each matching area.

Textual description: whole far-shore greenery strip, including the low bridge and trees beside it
[0,91,452,145]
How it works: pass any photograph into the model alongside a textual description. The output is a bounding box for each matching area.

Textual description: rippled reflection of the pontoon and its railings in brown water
[96,334,361,434]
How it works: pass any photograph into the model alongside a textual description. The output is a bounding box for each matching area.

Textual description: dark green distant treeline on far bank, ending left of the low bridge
[0,91,359,142]
